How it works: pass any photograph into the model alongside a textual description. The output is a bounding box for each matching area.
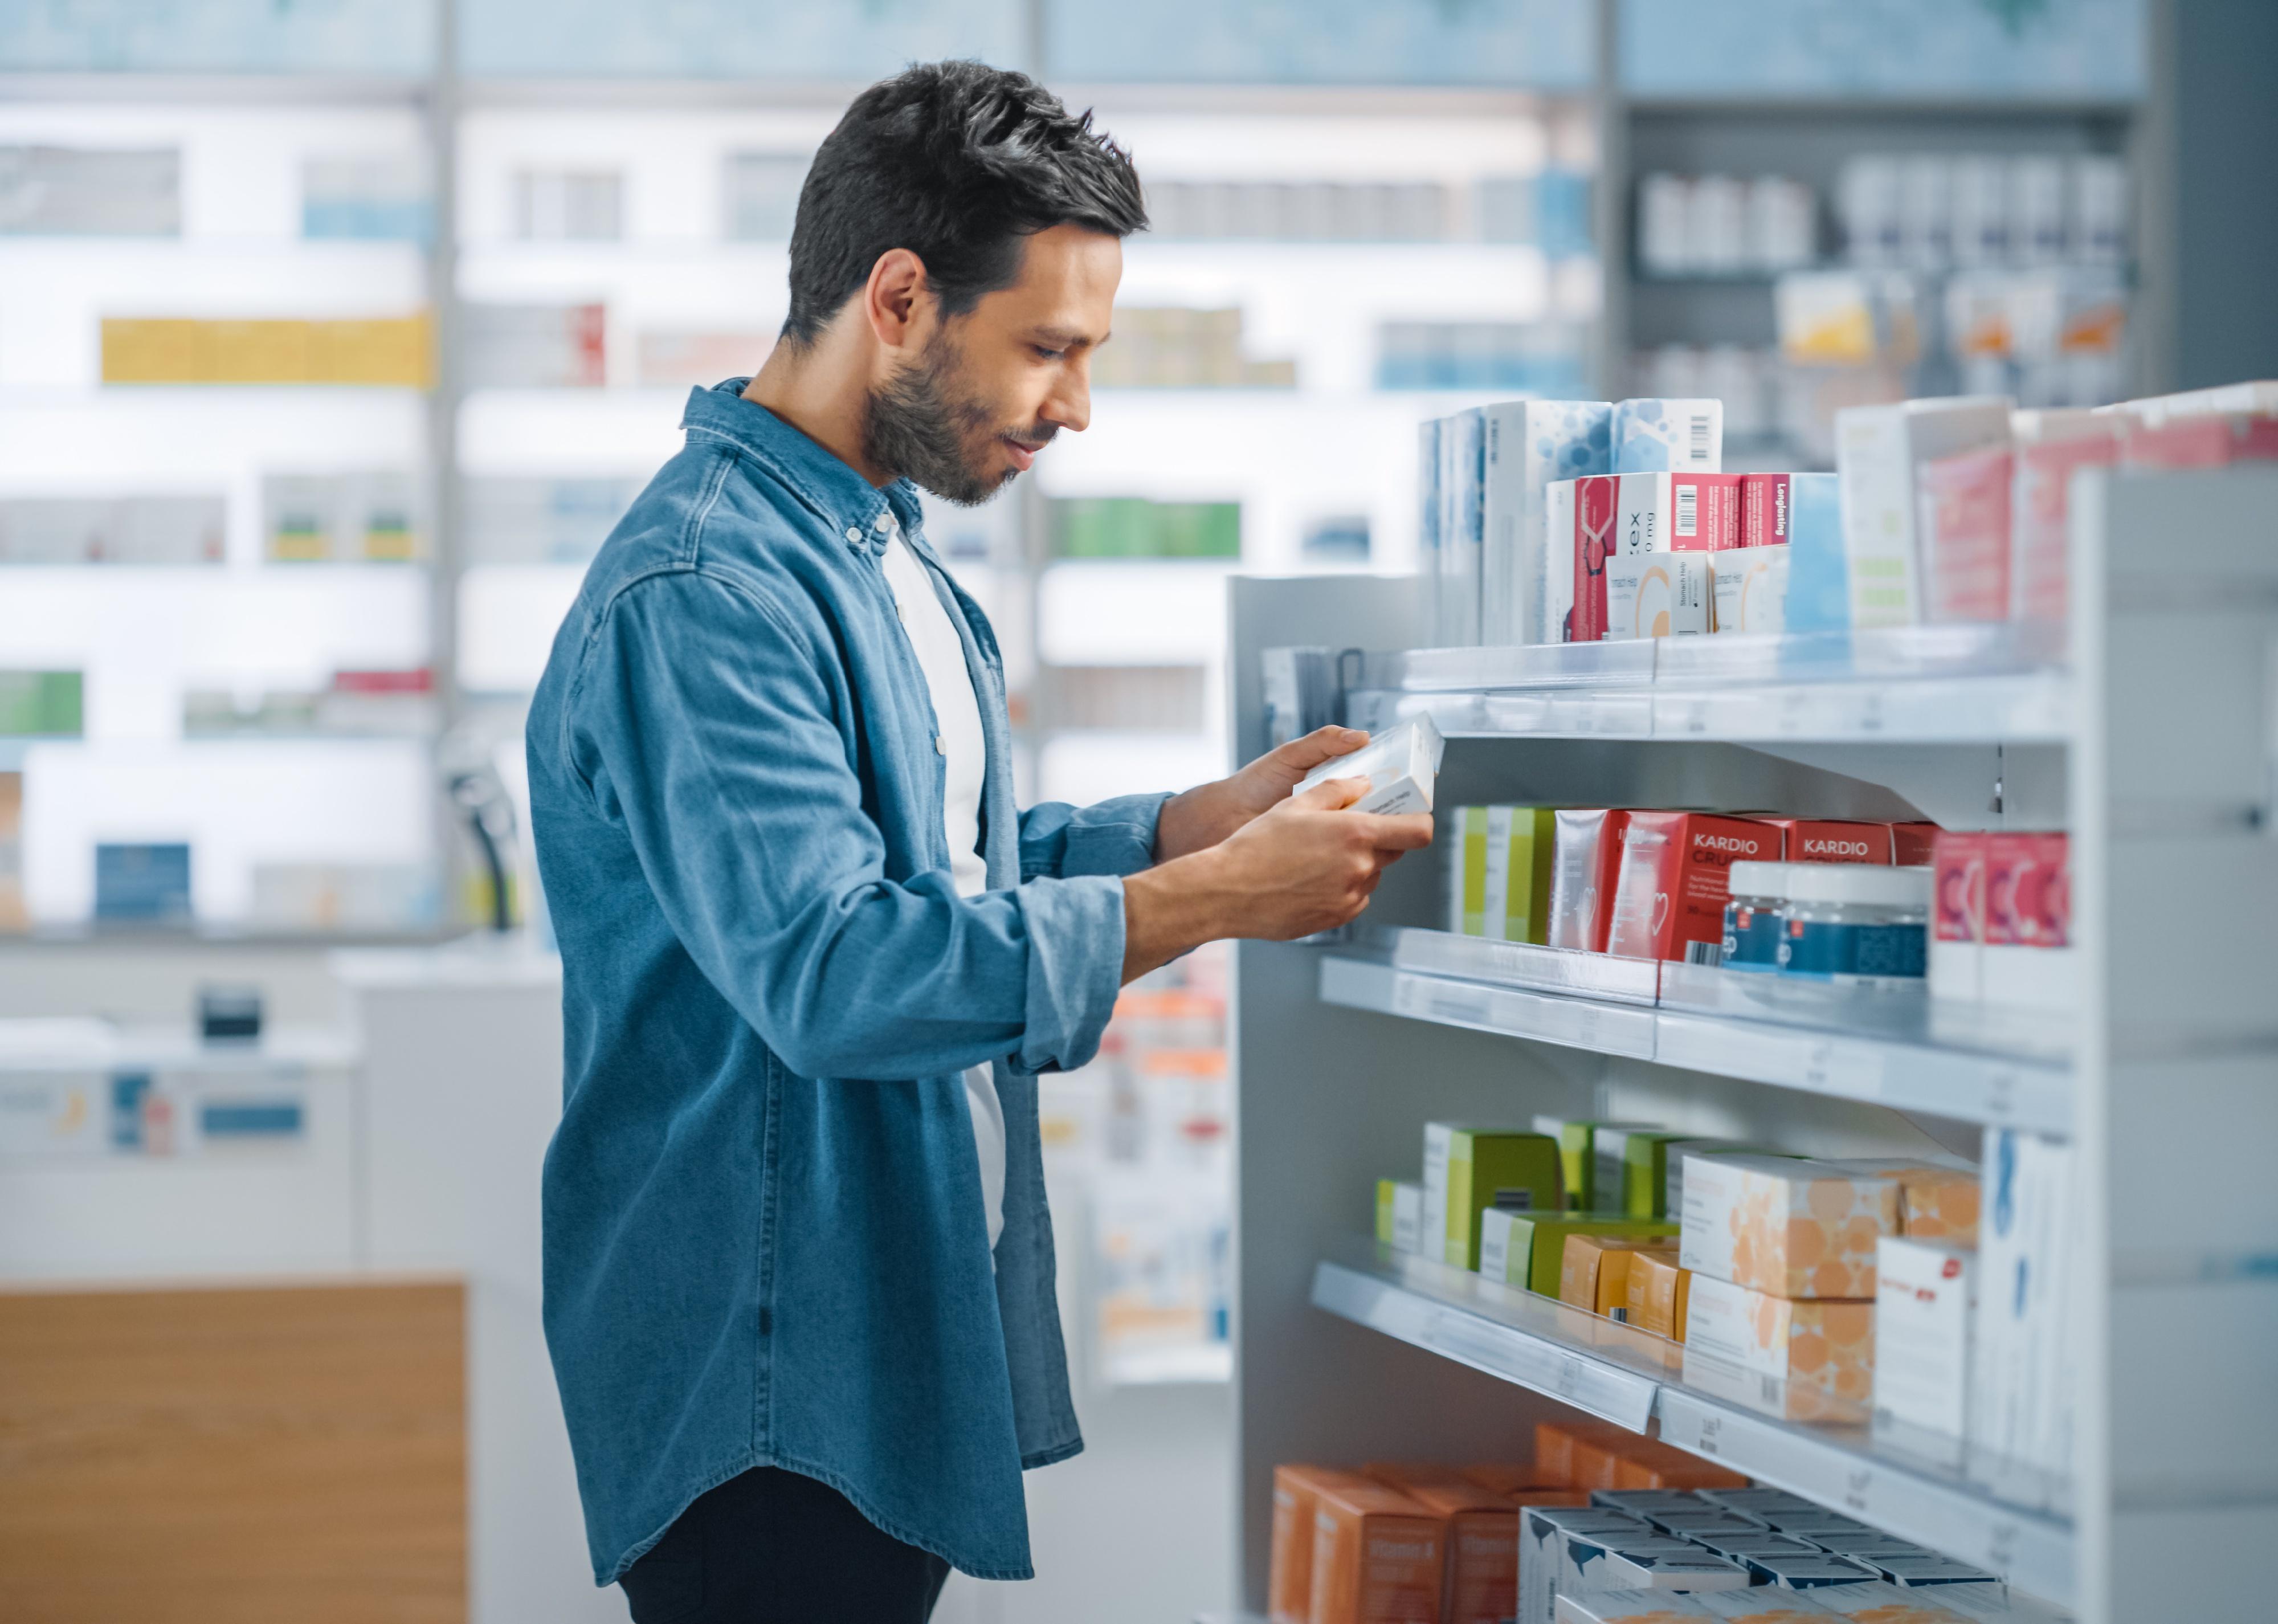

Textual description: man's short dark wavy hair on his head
[783,62,1146,346]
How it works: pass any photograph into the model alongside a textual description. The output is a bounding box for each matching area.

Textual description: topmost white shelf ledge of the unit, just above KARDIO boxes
[1344,624,2073,742]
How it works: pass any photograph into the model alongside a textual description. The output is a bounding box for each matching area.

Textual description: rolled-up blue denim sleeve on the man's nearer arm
[565,569,1123,1080]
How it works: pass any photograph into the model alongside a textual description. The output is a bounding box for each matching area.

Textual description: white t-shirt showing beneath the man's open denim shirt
[886,526,1005,1250]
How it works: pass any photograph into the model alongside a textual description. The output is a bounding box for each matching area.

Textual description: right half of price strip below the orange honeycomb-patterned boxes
[1659,1387,2073,1601]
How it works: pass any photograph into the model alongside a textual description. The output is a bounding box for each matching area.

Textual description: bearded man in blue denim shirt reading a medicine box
[529,62,1431,1624]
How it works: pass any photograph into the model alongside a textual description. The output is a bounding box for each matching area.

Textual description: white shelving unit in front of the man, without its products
[1230,469,2278,1624]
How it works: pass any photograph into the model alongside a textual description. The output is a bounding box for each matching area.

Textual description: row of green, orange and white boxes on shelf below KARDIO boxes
[1376,1116,2032,1464]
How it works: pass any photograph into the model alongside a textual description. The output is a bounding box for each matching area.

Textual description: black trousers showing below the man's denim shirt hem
[622,1467,950,1624]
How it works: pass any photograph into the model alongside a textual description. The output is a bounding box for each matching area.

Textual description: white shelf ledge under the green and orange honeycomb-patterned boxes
[1312,1241,2073,1601]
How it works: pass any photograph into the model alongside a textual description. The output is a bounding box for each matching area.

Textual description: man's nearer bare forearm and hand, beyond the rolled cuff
[1123,779,1431,982]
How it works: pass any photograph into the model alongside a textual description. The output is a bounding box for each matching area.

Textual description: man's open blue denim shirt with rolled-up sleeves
[526,378,1164,1583]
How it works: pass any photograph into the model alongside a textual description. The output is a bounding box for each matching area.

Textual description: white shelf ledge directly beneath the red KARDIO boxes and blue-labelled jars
[1319,929,2073,1137]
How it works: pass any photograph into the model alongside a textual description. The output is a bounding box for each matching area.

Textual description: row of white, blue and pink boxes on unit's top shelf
[1419,383,2278,644]
